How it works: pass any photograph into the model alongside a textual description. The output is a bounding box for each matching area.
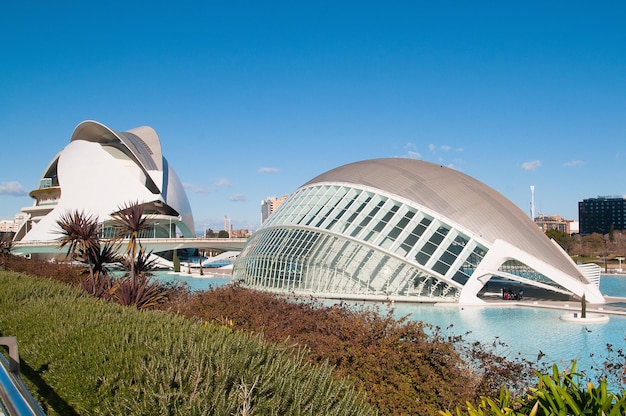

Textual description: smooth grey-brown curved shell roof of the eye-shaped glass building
[304,158,582,279]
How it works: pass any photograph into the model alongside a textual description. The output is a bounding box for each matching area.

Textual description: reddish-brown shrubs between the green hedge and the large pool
[168,285,512,415]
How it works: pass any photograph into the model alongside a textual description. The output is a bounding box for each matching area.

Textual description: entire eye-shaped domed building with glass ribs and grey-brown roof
[233,158,604,304]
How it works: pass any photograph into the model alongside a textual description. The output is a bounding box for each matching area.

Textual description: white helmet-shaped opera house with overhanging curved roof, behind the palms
[14,121,194,258]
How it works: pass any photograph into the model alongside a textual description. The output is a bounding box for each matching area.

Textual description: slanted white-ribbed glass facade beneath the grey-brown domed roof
[233,185,484,301]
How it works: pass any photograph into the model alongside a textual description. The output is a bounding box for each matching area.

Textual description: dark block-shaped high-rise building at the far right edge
[578,196,626,235]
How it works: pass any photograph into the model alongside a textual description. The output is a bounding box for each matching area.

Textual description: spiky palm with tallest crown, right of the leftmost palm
[112,202,150,278]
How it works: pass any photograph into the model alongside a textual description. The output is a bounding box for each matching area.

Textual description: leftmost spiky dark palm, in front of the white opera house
[57,210,100,288]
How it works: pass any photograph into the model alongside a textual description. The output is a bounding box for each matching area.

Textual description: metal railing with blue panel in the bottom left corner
[0,337,45,416]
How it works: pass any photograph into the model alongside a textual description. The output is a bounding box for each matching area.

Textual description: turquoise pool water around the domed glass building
[152,272,626,376]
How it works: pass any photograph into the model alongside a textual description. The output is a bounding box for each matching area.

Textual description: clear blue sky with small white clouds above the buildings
[0,0,626,230]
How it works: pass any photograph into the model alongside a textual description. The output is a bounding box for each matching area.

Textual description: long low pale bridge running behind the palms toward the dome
[11,238,248,255]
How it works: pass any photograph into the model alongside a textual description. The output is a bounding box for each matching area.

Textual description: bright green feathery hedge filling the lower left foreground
[0,271,374,415]
